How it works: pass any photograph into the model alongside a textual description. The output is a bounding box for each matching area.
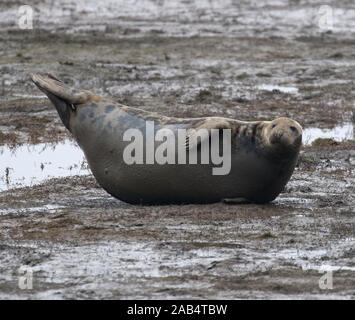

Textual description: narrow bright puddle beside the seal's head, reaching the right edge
[302,122,354,145]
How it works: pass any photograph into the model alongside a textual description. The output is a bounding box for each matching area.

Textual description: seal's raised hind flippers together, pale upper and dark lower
[30,73,98,131]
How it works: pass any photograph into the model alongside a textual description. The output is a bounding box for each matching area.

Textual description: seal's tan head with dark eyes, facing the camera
[264,118,302,152]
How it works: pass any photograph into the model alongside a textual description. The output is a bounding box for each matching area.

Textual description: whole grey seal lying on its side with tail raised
[31,74,302,204]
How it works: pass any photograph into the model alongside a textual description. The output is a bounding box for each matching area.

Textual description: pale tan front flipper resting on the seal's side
[185,117,232,150]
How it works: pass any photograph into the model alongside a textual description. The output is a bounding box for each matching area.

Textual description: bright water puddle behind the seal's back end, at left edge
[0,140,89,191]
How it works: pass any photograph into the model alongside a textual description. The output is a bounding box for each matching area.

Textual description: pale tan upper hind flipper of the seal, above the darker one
[30,73,95,105]
